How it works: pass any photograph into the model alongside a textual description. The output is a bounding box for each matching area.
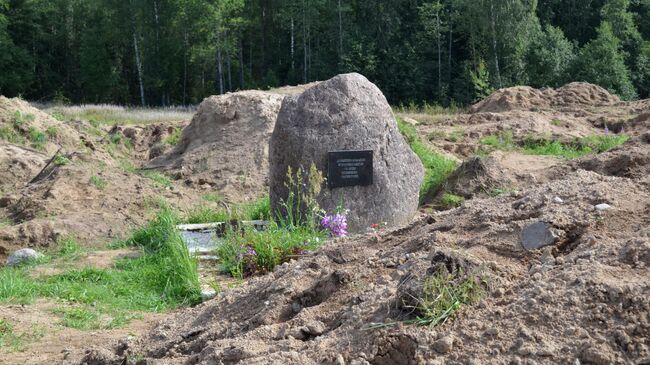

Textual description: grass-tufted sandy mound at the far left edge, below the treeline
[0,96,79,155]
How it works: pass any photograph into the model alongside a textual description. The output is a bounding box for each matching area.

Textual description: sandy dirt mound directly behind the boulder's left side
[147,91,284,201]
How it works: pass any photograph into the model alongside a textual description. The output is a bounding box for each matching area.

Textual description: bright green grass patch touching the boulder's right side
[397,118,456,202]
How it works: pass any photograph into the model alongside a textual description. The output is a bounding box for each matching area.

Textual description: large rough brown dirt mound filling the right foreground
[84,170,650,364]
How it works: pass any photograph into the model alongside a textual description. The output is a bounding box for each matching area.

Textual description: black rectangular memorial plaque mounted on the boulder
[327,151,372,189]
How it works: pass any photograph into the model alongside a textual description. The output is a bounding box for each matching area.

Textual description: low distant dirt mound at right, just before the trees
[470,82,620,113]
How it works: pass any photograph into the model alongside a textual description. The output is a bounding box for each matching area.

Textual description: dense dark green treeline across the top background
[0,0,650,105]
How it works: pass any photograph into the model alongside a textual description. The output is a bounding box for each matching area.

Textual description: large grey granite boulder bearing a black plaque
[269,73,424,232]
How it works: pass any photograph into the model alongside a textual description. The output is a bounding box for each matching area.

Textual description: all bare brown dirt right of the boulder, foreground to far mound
[73,84,650,364]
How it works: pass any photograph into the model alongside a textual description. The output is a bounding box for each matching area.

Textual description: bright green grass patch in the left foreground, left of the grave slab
[0,208,200,329]
